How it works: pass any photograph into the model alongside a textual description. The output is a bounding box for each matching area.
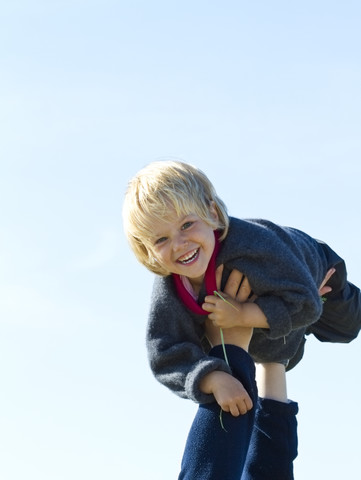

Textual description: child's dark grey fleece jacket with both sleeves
[146,217,328,403]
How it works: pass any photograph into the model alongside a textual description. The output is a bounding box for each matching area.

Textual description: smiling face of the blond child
[152,209,218,285]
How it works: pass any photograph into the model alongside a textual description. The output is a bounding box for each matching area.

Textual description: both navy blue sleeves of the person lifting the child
[178,345,298,480]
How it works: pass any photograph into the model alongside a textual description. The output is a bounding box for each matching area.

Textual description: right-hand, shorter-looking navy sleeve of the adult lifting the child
[242,398,298,480]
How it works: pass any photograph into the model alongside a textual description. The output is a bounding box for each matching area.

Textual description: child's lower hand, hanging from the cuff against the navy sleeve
[200,370,253,417]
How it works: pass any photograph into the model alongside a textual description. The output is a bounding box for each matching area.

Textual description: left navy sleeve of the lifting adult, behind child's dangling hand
[179,345,257,480]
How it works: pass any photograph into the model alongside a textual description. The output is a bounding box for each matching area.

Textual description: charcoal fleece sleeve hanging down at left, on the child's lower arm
[146,277,231,403]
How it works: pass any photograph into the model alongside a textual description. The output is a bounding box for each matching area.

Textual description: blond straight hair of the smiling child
[123,161,229,275]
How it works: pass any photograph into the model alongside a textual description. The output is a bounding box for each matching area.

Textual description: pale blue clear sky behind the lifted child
[0,0,361,480]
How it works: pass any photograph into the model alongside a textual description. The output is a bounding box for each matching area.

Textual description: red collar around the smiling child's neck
[172,230,220,315]
